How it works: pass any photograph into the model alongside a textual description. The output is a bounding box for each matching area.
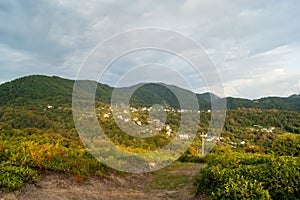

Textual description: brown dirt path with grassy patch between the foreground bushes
[0,163,208,200]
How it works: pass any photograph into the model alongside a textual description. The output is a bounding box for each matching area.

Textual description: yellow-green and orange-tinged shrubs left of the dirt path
[0,129,107,191]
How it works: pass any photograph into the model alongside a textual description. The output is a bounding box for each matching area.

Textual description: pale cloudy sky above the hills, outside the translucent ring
[0,0,300,99]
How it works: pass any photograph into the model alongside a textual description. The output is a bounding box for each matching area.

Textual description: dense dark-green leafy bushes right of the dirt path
[195,152,300,200]
